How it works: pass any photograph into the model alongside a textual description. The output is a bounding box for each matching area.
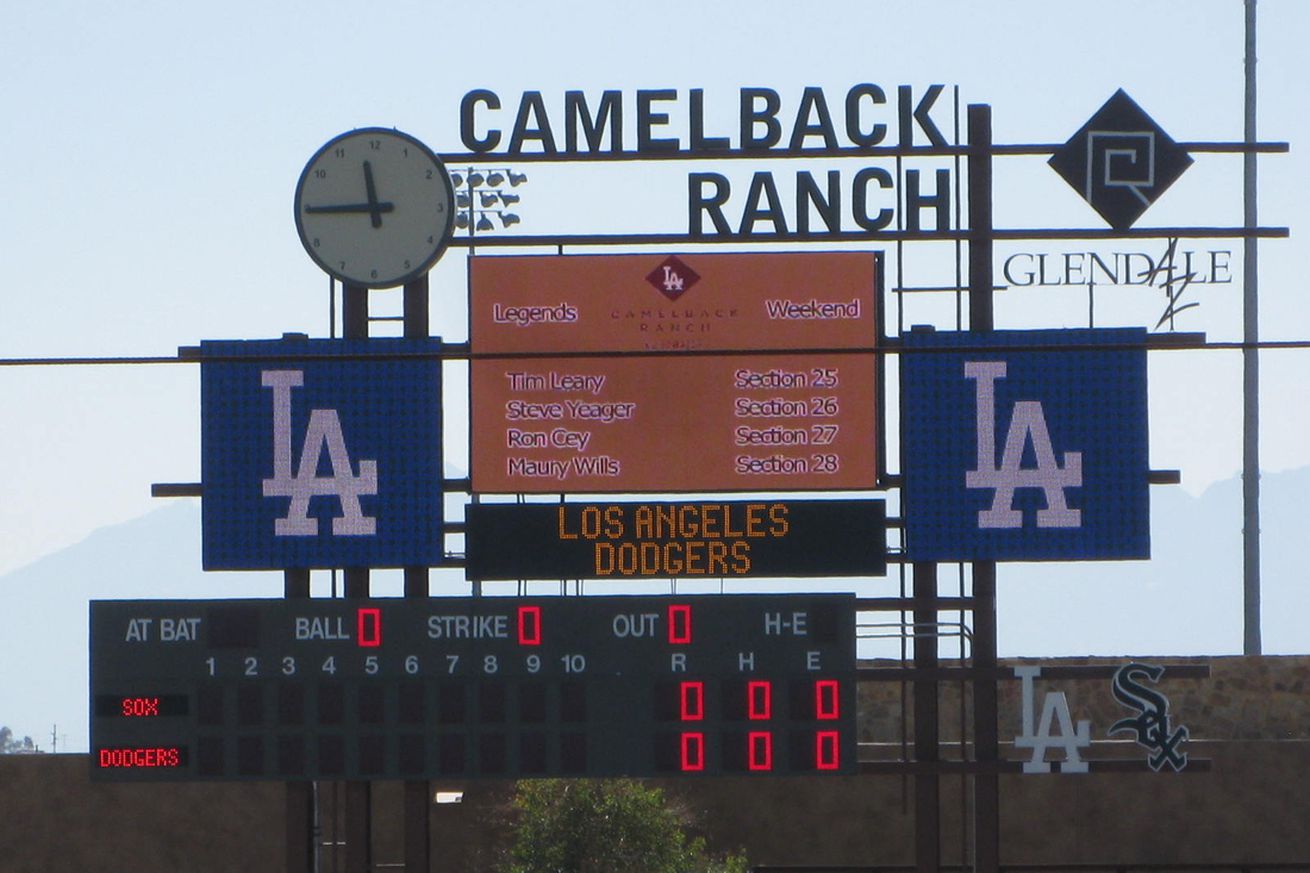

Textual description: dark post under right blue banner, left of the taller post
[913,562,942,873]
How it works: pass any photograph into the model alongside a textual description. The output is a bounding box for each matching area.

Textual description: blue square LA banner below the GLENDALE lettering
[900,328,1150,561]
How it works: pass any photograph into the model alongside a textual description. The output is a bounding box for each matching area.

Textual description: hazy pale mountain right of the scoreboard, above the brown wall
[997,468,1310,655]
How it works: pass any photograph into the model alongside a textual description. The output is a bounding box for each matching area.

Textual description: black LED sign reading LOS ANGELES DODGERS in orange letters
[465,499,887,579]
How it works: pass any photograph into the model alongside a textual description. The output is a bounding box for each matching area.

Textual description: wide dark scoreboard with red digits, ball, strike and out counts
[90,595,855,780]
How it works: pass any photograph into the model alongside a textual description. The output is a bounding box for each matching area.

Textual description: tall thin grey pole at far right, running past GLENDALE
[1242,0,1262,655]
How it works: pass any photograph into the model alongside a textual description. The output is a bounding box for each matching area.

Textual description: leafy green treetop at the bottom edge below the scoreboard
[503,779,747,873]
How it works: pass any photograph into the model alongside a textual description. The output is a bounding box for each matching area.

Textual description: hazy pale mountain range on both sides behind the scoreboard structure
[0,468,1310,751]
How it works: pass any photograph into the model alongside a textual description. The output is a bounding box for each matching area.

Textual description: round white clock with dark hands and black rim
[296,127,455,288]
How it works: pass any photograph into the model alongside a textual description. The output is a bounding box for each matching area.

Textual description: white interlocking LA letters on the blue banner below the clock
[261,370,377,536]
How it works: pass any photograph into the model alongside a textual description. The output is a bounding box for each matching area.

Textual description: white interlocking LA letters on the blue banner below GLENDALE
[964,360,1082,528]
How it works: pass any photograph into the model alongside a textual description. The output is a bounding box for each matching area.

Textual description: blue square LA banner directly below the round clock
[200,338,443,570]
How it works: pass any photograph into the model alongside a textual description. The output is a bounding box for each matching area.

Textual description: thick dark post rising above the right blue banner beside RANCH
[967,105,1001,873]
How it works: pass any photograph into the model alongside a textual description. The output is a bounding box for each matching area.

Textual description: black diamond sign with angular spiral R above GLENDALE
[1049,88,1192,231]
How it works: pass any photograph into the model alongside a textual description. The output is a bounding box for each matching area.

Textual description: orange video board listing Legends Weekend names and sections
[469,253,876,493]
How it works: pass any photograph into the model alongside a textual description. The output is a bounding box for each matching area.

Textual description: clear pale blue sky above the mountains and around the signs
[0,0,1310,572]
